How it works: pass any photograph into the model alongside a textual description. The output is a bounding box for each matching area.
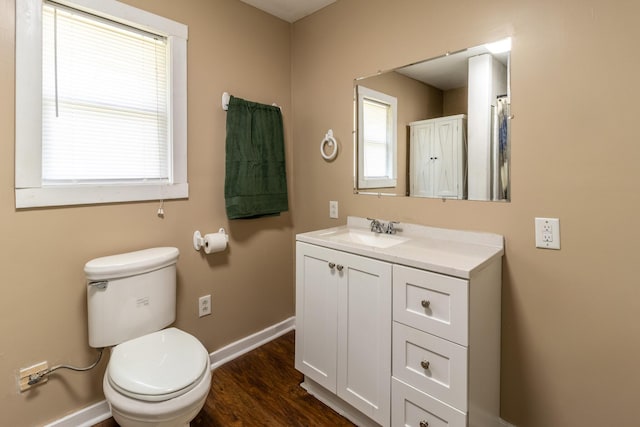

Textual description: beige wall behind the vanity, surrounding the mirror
[292,0,640,427]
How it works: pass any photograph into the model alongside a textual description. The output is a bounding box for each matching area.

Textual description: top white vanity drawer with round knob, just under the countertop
[393,265,469,346]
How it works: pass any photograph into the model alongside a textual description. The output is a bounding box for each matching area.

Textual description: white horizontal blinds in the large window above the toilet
[42,3,172,185]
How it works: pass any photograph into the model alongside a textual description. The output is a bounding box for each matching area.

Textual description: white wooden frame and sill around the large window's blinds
[15,0,189,208]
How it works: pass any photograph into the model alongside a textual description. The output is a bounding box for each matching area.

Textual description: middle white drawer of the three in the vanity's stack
[392,322,468,412]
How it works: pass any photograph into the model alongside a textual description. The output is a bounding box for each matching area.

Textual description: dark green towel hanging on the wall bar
[224,96,289,219]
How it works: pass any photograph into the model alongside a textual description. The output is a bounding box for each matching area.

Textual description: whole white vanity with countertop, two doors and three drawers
[295,217,504,427]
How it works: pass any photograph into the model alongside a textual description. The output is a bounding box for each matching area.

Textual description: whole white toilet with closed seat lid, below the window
[84,247,211,427]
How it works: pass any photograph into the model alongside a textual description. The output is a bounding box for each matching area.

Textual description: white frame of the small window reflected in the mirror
[356,85,398,188]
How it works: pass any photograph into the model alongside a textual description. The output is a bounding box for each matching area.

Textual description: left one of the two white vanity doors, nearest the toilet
[295,242,339,393]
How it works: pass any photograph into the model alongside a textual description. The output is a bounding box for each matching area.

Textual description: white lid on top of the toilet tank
[84,247,180,280]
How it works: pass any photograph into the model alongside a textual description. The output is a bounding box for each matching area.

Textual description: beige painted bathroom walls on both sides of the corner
[0,0,640,427]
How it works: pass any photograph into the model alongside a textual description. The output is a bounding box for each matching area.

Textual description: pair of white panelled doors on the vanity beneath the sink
[295,242,392,426]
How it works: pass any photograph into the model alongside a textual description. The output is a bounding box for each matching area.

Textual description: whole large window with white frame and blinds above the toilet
[16,0,188,208]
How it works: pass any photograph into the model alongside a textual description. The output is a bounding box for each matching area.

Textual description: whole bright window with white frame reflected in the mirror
[357,86,398,188]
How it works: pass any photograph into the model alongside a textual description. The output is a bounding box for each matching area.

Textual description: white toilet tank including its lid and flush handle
[84,247,180,348]
